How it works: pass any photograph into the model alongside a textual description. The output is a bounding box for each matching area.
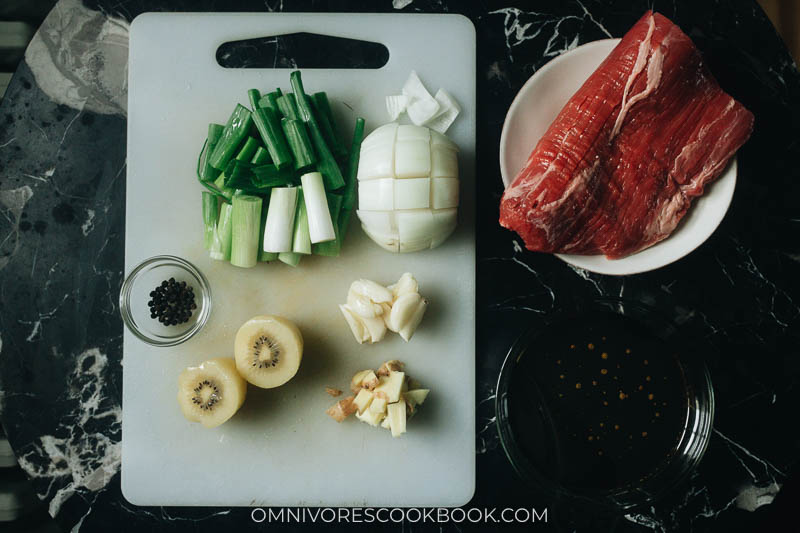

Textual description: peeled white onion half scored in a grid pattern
[357,122,459,252]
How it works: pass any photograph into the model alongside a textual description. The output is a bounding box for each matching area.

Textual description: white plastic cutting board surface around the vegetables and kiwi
[122,13,475,506]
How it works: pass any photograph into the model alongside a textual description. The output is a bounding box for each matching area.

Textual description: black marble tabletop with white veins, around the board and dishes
[0,0,800,532]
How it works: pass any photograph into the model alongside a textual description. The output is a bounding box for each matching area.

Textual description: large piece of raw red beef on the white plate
[500,11,753,259]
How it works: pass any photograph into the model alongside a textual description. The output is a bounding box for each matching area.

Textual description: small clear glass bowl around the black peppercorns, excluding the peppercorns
[119,255,211,346]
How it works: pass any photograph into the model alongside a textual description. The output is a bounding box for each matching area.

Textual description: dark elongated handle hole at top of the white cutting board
[217,32,389,69]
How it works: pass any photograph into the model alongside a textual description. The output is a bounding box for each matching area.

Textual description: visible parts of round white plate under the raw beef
[500,39,736,276]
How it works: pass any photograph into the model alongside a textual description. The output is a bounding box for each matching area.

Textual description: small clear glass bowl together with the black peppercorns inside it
[119,255,211,346]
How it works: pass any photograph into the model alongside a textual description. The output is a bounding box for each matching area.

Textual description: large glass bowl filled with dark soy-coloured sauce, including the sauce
[495,299,714,510]
